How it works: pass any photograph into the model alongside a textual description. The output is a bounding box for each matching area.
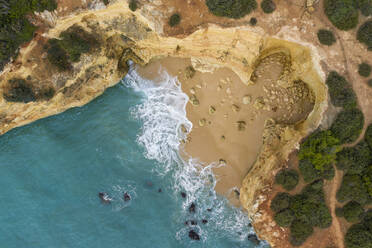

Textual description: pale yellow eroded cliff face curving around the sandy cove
[0,0,327,245]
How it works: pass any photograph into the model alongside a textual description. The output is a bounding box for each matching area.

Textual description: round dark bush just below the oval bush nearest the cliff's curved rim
[330,108,364,144]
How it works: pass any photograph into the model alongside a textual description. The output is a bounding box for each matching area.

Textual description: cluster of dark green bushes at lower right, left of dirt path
[271,180,332,246]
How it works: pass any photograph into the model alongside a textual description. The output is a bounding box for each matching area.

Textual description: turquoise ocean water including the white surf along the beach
[0,66,267,248]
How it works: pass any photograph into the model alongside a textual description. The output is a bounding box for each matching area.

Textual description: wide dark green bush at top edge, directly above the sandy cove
[206,0,257,19]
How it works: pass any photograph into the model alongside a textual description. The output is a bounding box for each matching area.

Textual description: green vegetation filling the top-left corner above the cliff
[0,0,57,70]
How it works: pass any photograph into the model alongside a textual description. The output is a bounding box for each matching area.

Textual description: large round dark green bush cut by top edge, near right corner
[324,0,358,30]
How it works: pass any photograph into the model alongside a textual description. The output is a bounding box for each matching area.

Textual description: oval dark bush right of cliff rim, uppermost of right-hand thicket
[326,71,357,108]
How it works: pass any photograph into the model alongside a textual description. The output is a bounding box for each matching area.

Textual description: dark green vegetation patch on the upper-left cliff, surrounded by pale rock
[47,26,98,71]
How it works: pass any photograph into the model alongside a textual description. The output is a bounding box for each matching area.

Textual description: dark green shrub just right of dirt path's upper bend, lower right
[336,174,372,206]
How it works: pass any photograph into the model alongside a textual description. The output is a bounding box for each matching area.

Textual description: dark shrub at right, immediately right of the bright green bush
[336,141,372,174]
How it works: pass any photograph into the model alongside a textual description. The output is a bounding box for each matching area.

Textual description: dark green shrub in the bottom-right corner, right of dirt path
[345,223,372,248]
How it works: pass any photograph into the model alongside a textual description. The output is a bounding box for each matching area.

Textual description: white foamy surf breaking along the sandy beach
[123,67,264,247]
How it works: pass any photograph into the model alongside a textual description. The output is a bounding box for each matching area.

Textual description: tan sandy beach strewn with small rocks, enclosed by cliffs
[139,56,312,205]
